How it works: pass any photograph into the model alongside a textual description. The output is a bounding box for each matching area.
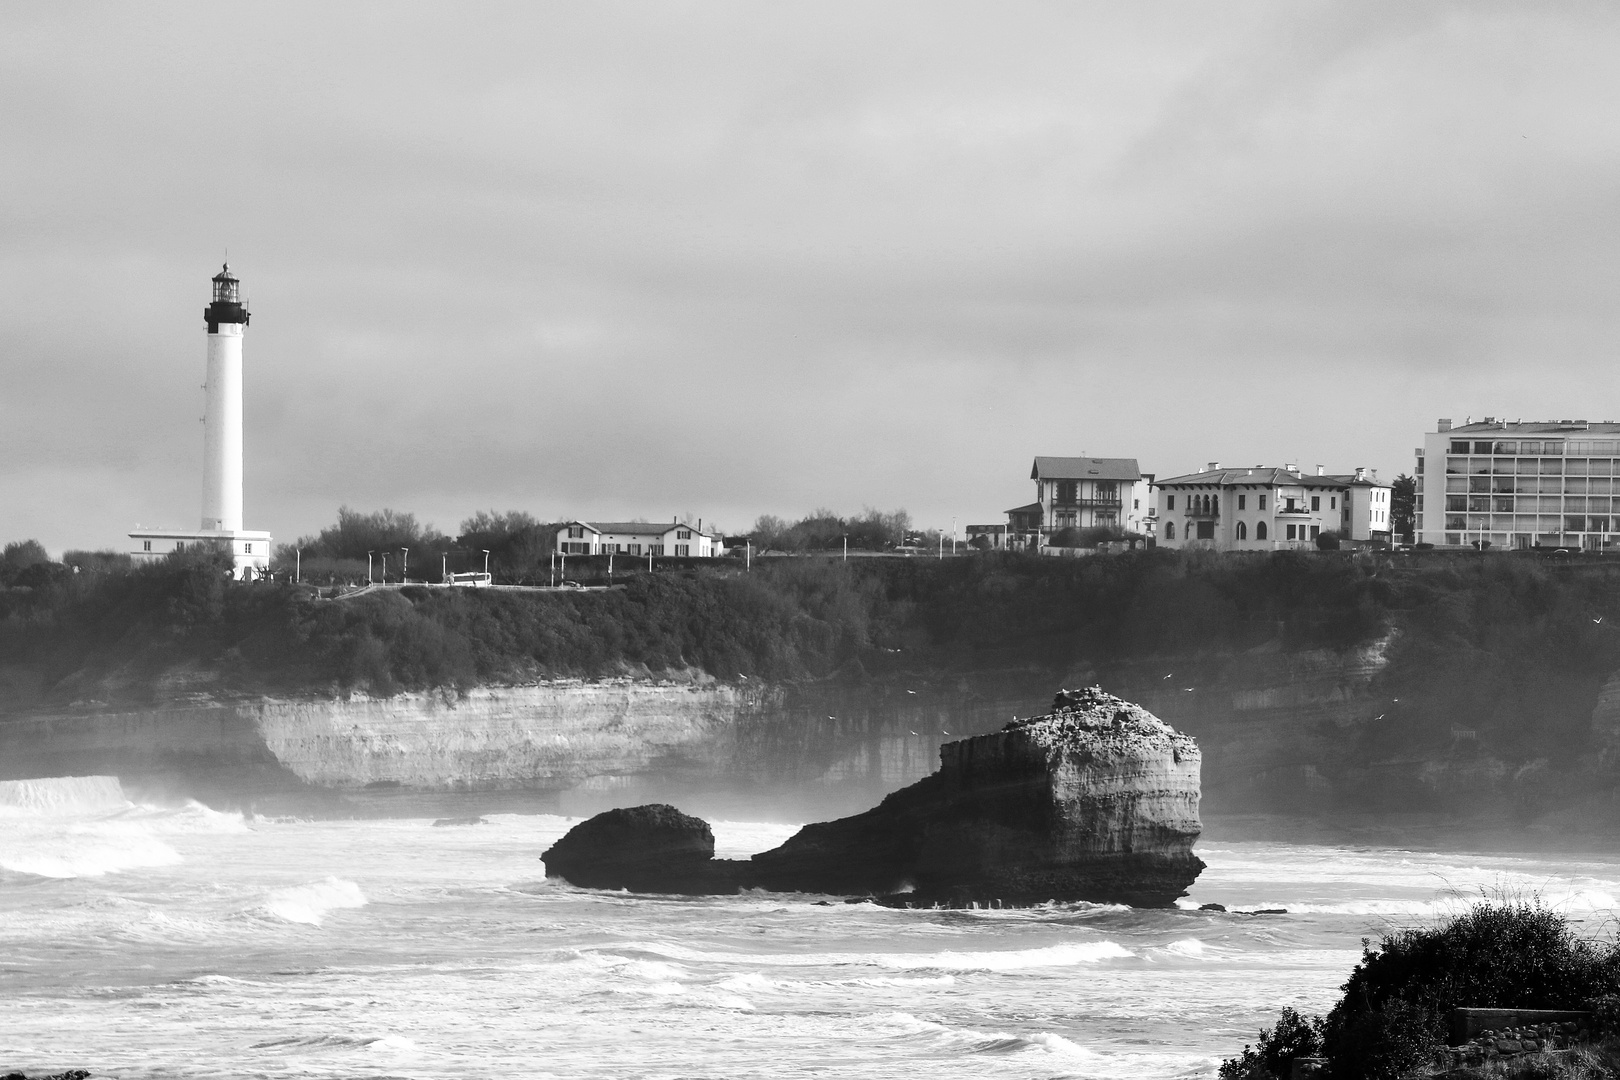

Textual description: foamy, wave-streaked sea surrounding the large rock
[0,777,1620,1080]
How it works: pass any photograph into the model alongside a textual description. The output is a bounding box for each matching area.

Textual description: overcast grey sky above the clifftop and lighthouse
[0,0,1620,551]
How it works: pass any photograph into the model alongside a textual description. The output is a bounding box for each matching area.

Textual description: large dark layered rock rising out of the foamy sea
[543,688,1204,907]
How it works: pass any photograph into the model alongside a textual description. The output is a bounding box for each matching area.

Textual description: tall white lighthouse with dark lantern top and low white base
[130,264,271,578]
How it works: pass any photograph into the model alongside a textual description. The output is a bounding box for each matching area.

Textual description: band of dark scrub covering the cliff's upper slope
[0,551,1620,705]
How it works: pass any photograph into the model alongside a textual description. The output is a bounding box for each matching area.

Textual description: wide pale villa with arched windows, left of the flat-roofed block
[1153,461,1390,551]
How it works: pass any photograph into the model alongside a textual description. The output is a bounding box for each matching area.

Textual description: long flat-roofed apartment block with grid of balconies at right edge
[1414,416,1620,551]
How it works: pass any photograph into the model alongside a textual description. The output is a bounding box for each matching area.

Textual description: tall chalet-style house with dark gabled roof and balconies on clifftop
[1006,457,1153,549]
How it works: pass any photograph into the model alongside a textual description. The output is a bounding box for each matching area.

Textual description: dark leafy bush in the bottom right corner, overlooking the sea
[1220,902,1620,1080]
